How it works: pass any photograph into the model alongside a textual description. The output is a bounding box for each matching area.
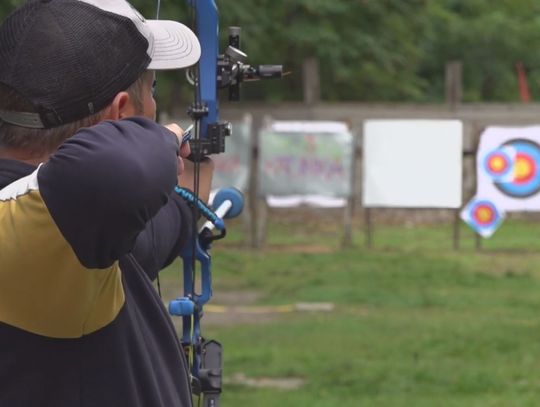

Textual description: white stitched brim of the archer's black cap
[146,20,201,70]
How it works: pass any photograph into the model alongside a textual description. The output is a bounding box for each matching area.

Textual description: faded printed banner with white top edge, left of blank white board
[259,122,353,199]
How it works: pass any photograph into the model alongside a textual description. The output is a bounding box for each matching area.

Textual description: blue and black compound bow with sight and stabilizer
[169,0,282,407]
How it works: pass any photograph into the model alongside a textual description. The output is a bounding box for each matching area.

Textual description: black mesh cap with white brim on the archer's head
[0,0,200,128]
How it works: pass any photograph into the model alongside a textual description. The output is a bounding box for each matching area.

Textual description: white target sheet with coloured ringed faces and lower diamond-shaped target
[461,126,540,237]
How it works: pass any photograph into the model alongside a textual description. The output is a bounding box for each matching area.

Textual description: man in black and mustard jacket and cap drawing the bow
[0,0,212,407]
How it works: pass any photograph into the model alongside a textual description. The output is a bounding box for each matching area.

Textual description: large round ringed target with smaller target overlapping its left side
[483,139,540,198]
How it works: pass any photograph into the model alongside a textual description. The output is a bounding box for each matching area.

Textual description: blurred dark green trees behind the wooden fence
[0,0,540,106]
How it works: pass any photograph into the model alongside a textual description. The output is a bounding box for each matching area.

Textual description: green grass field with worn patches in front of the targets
[162,215,540,407]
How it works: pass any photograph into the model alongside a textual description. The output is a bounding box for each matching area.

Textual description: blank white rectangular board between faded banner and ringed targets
[362,120,463,208]
